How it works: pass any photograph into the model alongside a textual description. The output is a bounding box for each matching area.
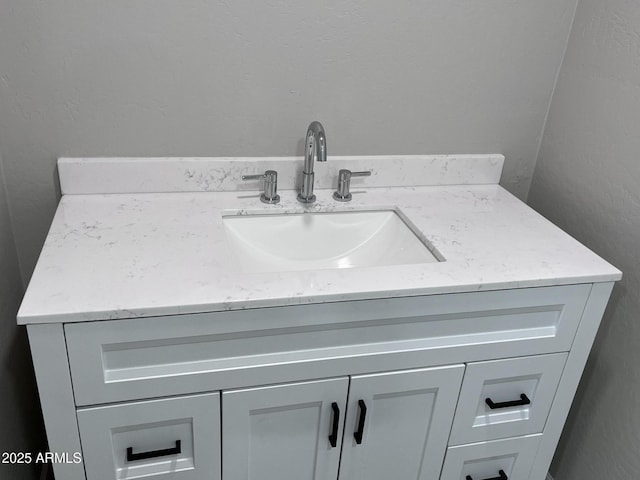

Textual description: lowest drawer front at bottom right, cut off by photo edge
[440,434,542,480]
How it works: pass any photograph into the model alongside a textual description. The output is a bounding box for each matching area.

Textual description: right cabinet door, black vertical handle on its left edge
[340,365,464,480]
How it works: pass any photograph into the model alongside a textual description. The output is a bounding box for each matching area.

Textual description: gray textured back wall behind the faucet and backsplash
[0,0,577,278]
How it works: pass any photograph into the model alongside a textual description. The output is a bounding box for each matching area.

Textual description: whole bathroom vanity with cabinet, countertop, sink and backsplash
[18,155,621,480]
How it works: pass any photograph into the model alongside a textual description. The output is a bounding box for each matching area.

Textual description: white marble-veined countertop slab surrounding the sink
[18,185,621,324]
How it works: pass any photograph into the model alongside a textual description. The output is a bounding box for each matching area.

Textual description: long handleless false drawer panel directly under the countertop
[65,285,591,405]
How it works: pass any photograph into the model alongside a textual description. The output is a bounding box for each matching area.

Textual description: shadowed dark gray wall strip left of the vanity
[0,150,44,480]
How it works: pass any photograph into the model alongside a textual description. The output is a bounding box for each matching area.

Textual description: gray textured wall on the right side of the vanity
[529,0,640,480]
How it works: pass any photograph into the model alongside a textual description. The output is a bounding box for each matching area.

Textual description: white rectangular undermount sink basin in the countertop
[222,210,439,273]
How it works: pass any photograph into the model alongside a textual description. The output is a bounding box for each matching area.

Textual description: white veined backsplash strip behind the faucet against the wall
[58,154,504,195]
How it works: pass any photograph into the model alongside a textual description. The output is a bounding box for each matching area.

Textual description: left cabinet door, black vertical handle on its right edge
[222,377,349,480]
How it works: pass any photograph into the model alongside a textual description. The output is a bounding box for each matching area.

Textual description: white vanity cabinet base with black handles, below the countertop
[29,283,612,480]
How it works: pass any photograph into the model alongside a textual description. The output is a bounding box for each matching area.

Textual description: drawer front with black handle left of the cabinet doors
[77,393,221,480]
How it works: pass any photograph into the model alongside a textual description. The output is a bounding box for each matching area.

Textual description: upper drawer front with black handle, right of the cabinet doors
[449,353,568,445]
